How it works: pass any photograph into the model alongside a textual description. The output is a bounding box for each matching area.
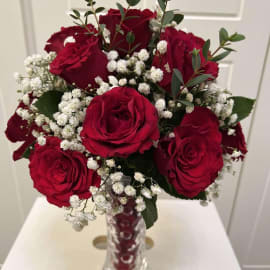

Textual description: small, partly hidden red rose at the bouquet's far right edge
[222,123,247,160]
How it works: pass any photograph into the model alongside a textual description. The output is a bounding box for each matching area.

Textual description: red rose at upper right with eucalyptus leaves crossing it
[153,27,218,92]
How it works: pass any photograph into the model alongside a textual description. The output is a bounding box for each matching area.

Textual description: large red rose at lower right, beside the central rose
[155,107,223,198]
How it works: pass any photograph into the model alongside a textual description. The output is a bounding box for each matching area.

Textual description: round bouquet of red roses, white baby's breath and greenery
[6,0,255,230]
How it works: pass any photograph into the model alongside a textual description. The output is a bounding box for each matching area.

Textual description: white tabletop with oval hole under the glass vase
[2,198,240,270]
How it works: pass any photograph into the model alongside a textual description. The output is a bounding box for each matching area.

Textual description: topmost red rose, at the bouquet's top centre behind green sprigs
[99,9,156,56]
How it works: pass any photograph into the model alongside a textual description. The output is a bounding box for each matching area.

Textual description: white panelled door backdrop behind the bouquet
[0,0,270,270]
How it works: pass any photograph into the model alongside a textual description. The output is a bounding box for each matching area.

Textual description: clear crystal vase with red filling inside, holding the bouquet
[103,177,147,270]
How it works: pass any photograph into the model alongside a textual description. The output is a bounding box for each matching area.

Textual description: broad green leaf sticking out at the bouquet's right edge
[231,96,256,122]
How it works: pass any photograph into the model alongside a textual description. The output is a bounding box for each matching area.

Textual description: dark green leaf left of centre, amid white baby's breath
[34,91,63,120]
